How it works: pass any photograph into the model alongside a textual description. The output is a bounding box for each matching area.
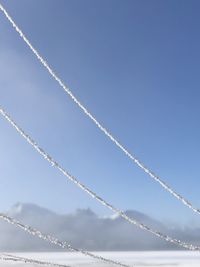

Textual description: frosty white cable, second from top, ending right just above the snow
[0,107,200,253]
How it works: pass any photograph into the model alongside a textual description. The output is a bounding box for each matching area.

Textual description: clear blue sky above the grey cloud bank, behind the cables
[0,0,200,226]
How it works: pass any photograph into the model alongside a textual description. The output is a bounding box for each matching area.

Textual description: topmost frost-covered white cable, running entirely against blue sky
[0,4,200,218]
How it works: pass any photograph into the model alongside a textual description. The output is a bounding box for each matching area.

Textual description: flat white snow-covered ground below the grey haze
[0,251,200,267]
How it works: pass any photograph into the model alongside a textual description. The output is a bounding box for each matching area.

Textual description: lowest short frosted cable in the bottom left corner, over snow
[0,253,70,267]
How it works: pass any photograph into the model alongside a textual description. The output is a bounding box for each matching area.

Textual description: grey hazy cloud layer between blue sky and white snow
[0,204,200,251]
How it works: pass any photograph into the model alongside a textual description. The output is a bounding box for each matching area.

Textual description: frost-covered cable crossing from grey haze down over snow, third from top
[0,213,131,267]
